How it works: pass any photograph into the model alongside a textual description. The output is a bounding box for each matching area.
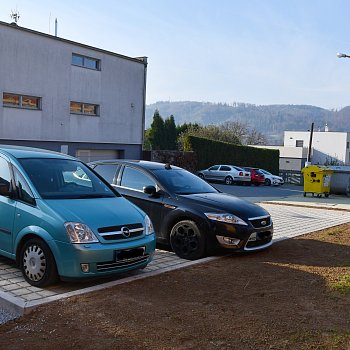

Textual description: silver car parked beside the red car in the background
[197,164,251,185]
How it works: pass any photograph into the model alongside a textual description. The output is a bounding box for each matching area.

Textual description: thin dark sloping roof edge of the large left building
[0,21,147,65]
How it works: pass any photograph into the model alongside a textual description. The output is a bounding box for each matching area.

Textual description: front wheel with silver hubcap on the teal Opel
[20,238,58,288]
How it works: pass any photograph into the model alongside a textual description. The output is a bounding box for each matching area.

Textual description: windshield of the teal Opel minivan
[19,158,116,199]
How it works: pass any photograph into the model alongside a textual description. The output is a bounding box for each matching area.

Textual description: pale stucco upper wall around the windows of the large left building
[0,23,145,144]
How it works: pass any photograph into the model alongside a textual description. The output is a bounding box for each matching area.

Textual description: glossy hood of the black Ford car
[179,193,270,219]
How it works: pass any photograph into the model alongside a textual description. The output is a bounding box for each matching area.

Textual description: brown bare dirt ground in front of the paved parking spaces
[0,225,350,350]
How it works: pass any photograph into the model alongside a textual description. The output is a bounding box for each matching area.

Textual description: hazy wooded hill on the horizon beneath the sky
[146,101,350,145]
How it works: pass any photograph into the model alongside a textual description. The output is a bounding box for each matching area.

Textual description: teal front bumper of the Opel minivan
[51,234,156,278]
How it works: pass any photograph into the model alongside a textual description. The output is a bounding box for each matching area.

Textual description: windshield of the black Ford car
[154,169,218,194]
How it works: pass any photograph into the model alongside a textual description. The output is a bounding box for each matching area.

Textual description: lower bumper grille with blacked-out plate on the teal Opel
[96,247,149,271]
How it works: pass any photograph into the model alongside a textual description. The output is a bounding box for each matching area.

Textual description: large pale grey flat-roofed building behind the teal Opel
[0,22,147,161]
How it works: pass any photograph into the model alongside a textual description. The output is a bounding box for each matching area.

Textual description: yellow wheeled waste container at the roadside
[302,165,333,197]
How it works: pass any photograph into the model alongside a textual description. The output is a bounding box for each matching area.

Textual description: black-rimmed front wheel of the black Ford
[170,220,206,260]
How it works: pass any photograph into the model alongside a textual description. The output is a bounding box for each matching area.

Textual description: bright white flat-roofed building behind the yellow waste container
[284,127,350,165]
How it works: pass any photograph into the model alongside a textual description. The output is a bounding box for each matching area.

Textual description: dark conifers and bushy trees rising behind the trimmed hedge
[144,109,266,151]
